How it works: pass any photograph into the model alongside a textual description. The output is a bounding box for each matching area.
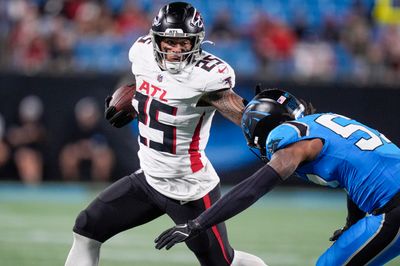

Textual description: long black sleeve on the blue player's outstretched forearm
[193,165,281,229]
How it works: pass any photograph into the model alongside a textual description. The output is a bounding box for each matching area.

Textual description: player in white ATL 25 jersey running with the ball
[66,2,265,266]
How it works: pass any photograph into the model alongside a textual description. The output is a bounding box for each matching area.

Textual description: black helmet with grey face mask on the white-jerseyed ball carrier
[150,2,205,74]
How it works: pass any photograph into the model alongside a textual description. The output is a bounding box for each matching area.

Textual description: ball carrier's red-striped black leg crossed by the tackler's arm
[166,186,265,266]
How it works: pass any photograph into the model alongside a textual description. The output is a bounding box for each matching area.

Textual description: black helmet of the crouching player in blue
[241,89,305,157]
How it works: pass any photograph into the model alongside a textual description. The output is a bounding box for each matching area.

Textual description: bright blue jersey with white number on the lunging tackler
[266,113,400,213]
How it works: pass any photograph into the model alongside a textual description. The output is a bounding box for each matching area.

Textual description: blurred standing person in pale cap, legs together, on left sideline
[7,95,47,184]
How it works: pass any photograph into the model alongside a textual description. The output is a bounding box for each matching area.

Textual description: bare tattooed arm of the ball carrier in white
[199,89,245,126]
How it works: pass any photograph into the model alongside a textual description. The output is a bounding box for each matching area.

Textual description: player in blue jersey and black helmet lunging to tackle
[156,89,400,265]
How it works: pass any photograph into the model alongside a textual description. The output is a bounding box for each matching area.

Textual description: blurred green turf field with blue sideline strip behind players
[0,183,400,266]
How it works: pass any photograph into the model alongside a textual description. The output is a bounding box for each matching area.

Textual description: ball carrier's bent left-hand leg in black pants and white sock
[65,171,164,266]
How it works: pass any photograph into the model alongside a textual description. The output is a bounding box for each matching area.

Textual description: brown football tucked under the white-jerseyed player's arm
[110,84,136,117]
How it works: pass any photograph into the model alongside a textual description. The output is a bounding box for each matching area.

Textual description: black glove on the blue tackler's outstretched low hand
[154,221,202,250]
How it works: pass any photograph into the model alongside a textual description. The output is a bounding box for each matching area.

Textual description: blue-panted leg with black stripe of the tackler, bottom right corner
[317,208,400,266]
